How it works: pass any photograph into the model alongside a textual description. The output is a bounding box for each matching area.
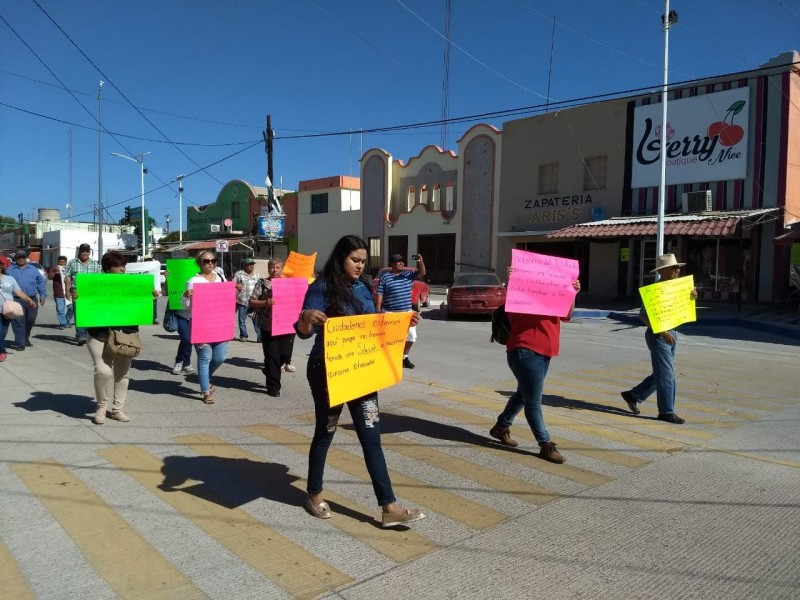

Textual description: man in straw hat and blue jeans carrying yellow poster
[621,254,697,425]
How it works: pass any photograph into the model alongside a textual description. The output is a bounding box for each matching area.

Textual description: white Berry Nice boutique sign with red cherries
[631,87,750,188]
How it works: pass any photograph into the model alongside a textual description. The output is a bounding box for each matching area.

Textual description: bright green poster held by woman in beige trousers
[75,273,153,327]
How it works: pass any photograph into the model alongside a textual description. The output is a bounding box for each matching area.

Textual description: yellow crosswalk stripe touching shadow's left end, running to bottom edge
[98,446,353,598]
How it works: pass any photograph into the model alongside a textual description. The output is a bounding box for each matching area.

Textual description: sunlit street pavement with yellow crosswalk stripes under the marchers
[0,288,800,600]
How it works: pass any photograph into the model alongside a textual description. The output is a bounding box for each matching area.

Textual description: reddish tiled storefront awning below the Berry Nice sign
[547,208,779,238]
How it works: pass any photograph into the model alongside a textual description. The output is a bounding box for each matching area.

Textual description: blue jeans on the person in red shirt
[497,348,550,445]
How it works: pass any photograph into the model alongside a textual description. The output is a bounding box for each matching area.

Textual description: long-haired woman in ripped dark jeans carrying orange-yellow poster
[295,235,425,527]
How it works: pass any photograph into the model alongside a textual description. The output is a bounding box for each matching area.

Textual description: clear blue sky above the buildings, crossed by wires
[0,0,800,230]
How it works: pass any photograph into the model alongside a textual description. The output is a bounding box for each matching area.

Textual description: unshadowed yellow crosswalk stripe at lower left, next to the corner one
[11,459,205,598]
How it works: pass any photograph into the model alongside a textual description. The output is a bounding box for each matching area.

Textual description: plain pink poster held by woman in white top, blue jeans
[190,281,236,344]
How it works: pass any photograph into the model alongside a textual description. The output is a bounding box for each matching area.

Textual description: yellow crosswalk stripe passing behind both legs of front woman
[243,424,508,529]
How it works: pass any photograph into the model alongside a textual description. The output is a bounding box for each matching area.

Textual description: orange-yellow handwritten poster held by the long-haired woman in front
[325,312,412,406]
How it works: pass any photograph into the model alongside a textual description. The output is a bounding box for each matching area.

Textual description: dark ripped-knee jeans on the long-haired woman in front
[306,359,397,506]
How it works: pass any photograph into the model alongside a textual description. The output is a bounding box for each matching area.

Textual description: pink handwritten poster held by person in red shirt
[506,250,578,317]
